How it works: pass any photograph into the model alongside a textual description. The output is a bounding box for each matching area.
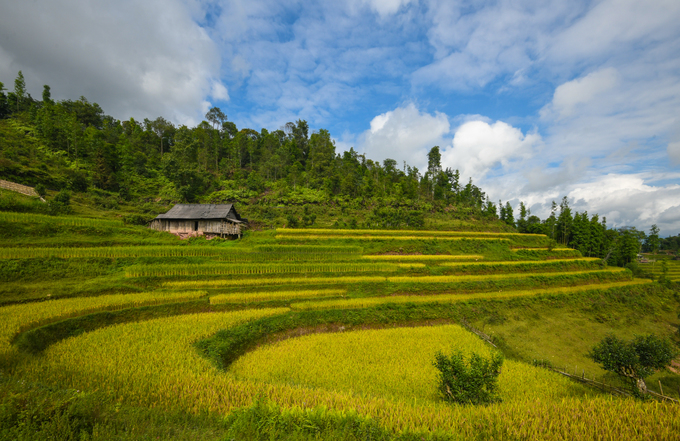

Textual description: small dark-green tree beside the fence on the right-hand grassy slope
[588,334,677,396]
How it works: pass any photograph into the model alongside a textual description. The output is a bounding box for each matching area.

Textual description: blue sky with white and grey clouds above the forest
[0,0,680,237]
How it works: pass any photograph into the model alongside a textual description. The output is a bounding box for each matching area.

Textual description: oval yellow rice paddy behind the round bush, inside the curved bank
[229,325,592,404]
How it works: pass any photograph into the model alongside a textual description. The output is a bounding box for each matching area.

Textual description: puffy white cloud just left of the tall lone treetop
[361,103,450,170]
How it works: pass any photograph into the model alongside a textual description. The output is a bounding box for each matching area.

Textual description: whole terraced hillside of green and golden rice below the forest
[0,214,680,440]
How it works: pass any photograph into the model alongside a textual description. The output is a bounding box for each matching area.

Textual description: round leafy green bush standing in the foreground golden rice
[434,351,503,404]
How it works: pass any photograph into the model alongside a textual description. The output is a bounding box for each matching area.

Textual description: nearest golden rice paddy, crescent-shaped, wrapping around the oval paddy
[11,309,680,440]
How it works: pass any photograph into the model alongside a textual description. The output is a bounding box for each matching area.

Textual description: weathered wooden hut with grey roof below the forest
[149,204,247,239]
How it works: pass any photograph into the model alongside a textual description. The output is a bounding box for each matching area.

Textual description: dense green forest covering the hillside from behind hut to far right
[0,72,678,266]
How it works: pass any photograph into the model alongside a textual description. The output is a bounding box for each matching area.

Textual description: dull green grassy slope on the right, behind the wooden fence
[474,285,680,397]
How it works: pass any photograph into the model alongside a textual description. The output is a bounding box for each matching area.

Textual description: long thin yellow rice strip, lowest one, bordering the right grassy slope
[290,279,651,310]
